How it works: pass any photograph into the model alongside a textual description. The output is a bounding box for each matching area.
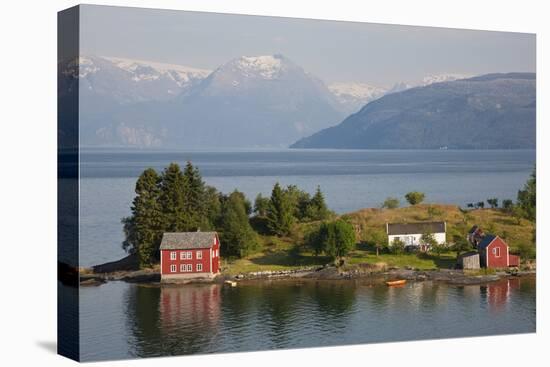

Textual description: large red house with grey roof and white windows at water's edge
[160,232,220,281]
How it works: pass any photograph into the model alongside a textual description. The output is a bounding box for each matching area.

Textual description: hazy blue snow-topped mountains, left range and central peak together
[66,55,346,148]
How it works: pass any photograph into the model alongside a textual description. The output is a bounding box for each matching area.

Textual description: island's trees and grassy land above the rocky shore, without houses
[112,162,536,275]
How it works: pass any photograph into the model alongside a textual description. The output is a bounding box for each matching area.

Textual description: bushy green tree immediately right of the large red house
[220,191,258,257]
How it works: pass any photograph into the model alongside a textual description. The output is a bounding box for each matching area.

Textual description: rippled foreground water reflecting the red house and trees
[80,278,536,361]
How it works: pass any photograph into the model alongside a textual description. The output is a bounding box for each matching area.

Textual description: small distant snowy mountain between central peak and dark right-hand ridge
[328,82,387,113]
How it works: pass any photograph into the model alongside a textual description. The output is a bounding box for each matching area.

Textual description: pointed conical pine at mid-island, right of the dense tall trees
[267,182,294,236]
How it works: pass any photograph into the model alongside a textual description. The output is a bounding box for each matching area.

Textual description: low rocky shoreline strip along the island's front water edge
[80,266,536,286]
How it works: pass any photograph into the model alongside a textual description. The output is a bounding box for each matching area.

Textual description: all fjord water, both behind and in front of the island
[79,150,536,360]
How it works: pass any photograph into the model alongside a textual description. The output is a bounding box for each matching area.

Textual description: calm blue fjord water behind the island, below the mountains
[80,149,535,266]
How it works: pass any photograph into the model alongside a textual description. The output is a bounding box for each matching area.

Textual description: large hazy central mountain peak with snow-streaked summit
[168,55,345,147]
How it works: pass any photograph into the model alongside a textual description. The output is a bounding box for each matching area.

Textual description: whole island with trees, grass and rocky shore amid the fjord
[80,162,536,285]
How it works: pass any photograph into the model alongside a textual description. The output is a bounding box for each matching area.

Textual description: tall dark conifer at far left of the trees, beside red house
[122,168,163,267]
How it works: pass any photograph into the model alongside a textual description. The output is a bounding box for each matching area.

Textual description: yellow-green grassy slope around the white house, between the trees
[223,204,534,274]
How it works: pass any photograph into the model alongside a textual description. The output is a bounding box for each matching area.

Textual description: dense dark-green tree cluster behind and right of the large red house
[122,162,333,267]
